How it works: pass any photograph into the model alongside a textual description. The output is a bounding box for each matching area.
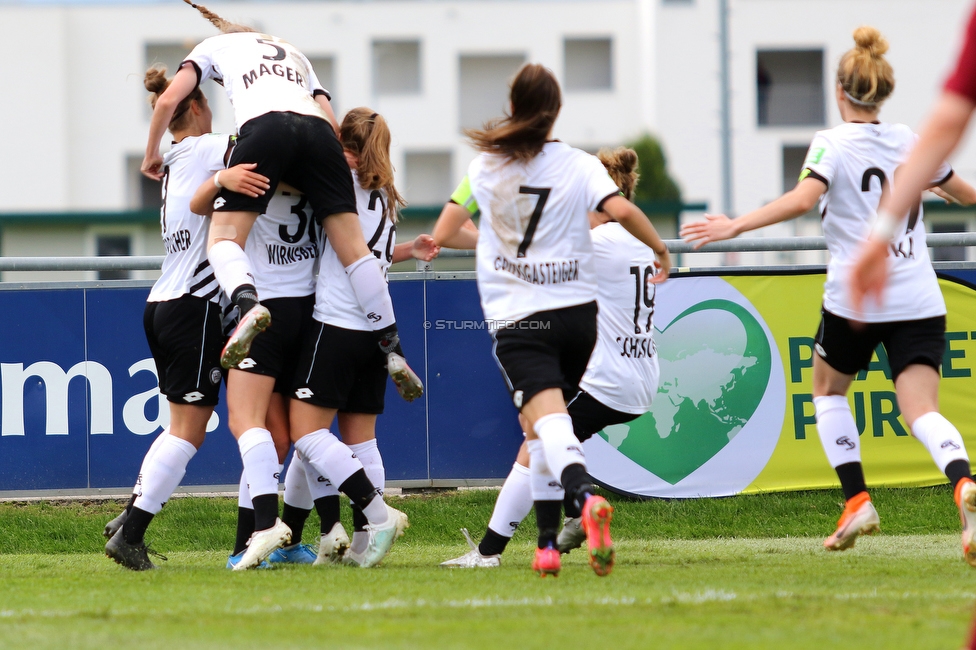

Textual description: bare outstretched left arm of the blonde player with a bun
[680,177,827,249]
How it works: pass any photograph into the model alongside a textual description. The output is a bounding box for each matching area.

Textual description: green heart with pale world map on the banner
[600,299,771,485]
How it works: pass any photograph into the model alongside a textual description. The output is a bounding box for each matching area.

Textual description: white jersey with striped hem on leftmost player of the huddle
[149,133,231,302]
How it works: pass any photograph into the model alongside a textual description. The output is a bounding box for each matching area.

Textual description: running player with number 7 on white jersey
[434,64,668,575]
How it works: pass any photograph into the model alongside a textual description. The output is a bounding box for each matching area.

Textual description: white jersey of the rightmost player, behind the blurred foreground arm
[801,122,952,323]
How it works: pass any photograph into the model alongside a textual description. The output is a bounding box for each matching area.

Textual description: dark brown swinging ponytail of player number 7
[464,63,562,162]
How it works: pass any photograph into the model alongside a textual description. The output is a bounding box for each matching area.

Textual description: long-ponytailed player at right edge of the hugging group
[290,108,437,567]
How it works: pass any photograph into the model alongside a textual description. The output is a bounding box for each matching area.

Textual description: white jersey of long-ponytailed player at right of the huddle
[315,171,396,332]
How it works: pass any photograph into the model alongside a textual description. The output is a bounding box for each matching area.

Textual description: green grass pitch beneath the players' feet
[0,487,976,650]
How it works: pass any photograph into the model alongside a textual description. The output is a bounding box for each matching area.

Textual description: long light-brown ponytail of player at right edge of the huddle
[339,107,407,223]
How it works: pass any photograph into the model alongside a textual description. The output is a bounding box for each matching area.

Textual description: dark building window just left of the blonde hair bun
[756,50,825,126]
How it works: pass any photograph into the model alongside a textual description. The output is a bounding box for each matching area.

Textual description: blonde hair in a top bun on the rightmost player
[837,27,895,110]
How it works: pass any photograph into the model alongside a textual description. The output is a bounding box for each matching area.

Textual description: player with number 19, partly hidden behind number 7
[441,148,670,569]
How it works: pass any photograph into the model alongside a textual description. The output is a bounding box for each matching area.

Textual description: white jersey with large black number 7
[464,142,619,329]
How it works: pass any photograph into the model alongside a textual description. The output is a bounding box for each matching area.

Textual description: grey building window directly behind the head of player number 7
[458,54,525,129]
